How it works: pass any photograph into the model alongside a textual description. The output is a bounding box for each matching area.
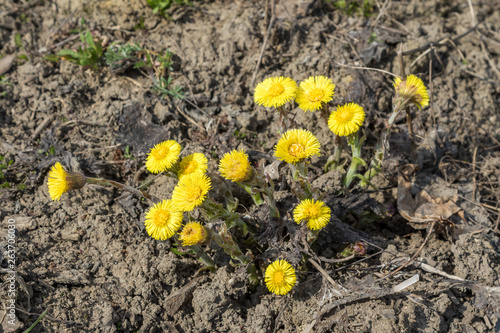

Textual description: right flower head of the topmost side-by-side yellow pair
[295,76,335,111]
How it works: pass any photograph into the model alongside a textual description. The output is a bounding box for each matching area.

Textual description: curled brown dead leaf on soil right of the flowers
[398,164,461,229]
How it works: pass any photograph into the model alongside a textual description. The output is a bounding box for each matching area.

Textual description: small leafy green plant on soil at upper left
[57,30,103,70]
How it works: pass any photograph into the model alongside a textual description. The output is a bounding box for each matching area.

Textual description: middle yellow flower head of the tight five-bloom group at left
[172,173,212,212]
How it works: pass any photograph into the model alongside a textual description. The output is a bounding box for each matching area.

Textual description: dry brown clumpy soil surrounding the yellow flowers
[0,0,500,332]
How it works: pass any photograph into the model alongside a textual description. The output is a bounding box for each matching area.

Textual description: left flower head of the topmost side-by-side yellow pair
[254,76,297,108]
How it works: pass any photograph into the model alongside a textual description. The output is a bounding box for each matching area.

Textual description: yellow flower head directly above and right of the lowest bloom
[293,199,331,230]
